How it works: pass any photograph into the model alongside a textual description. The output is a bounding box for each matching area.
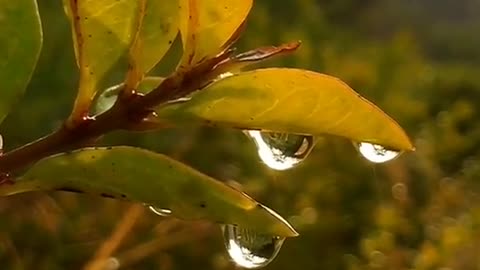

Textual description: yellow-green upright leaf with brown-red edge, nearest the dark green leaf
[64,0,138,117]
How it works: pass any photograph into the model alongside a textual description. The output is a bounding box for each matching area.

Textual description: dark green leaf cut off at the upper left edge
[0,0,42,123]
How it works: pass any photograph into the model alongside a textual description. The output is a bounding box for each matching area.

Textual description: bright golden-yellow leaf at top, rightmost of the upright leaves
[179,0,253,66]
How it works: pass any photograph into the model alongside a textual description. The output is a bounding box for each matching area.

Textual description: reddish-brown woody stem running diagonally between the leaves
[0,50,231,175]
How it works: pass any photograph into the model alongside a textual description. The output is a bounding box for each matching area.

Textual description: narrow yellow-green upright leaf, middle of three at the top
[126,0,178,89]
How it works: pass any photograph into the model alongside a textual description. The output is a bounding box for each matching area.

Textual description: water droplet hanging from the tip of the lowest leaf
[222,224,285,269]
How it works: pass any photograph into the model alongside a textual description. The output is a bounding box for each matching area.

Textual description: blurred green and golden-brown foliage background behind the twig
[0,0,480,270]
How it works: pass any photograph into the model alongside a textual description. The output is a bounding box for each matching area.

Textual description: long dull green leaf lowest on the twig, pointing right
[8,146,297,237]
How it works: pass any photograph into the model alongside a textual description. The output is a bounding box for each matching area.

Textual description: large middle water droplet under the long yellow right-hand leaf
[246,130,315,170]
